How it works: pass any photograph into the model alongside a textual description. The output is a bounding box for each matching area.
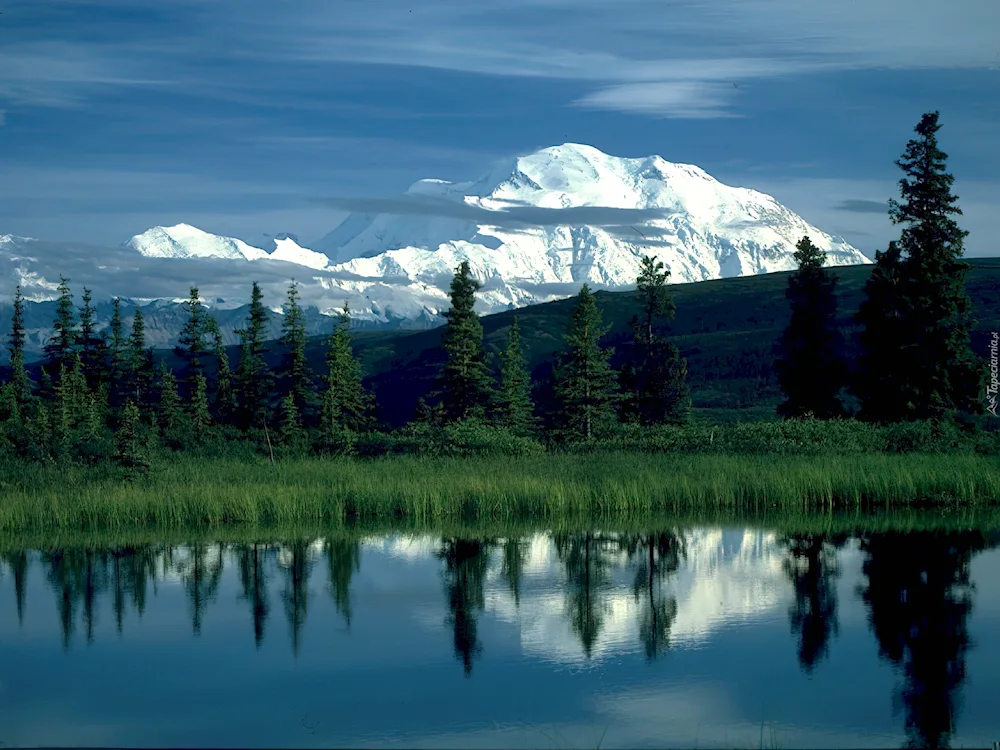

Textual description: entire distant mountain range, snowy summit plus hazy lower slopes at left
[0,143,871,362]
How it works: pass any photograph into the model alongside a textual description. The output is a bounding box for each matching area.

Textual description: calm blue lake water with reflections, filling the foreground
[0,528,1000,748]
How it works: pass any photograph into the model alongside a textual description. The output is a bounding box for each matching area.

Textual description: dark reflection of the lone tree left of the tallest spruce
[781,534,847,674]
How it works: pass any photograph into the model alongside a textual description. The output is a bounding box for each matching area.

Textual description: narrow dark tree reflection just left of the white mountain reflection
[438,538,490,677]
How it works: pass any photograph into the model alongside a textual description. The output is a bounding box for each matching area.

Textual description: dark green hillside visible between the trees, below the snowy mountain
[324,258,1000,424]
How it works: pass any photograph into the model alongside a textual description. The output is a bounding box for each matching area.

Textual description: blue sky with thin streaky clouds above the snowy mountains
[0,0,1000,255]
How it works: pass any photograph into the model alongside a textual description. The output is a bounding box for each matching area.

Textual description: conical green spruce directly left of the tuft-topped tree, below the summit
[555,284,618,440]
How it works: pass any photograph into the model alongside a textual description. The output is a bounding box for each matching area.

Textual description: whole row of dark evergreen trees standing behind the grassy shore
[0,112,986,469]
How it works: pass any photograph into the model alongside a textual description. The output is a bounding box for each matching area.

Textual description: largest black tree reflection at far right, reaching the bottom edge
[861,531,987,748]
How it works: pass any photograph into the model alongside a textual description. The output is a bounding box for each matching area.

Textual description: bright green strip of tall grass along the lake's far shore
[0,454,1000,533]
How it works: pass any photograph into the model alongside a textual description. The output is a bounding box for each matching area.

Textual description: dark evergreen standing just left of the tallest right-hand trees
[774,237,847,419]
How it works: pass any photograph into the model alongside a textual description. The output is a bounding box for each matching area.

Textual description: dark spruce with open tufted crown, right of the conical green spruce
[621,255,691,425]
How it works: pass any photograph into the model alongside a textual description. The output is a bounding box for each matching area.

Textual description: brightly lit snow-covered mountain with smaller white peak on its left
[129,143,871,317]
